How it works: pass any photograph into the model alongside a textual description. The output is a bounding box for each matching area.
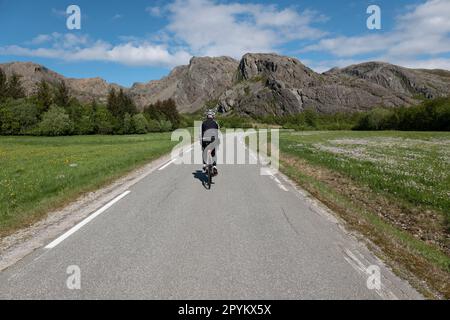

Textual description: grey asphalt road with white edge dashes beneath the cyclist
[0,141,421,299]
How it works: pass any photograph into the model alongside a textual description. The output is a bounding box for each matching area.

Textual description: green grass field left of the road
[0,133,176,235]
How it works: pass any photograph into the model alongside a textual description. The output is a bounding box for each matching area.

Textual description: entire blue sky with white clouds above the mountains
[0,0,450,86]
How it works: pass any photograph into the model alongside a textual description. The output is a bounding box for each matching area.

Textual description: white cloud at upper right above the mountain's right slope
[303,0,450,67]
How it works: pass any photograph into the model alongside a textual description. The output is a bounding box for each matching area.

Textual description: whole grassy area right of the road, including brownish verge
[280,132,450,298]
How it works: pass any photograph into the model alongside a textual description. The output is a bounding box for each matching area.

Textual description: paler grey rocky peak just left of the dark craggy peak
[130,57,238,112]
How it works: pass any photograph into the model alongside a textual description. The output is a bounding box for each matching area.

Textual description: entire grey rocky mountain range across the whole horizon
[0,54,450,115]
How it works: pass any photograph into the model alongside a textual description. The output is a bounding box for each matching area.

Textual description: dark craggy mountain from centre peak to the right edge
[219,54,450,115]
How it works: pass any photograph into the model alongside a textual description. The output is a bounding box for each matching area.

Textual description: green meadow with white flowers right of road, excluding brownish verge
[280,131,450,219]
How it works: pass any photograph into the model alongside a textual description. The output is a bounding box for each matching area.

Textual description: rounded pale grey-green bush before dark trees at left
[37,105,73,136]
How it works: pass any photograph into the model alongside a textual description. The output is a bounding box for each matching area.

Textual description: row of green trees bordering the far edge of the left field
[0,69,188,136]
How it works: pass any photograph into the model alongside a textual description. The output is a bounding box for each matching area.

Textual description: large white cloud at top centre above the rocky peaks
[166,0,324,58]
